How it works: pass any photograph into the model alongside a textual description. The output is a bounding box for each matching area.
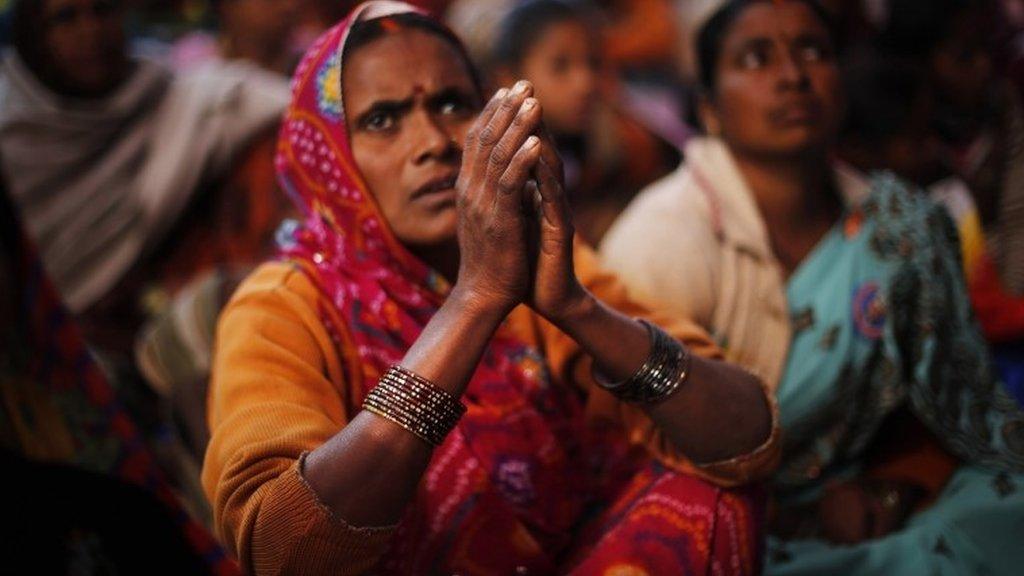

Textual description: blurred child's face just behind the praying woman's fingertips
[519,22,599,135]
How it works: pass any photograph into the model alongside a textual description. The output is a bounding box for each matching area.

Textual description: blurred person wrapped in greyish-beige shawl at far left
[0,0,288,351]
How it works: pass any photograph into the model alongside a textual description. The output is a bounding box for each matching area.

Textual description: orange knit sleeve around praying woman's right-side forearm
[539,243,780,486]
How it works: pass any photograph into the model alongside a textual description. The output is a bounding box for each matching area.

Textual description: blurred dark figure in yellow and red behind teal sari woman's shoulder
[838,50,1024,404]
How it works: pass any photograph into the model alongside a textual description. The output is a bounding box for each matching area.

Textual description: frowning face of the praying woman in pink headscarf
[342,29,480,251]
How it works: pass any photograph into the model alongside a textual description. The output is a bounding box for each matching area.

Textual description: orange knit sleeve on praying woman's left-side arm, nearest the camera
[203,263,393,575]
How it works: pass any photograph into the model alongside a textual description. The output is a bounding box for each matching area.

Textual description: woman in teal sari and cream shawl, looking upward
[601,0,1024,575]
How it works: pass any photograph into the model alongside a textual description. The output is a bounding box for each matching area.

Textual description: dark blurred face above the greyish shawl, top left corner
[40,0,128,96]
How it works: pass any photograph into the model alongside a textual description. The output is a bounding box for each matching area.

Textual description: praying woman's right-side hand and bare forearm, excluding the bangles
[523,126,773,463]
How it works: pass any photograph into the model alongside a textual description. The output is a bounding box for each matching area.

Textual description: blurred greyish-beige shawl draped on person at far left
[0,51,289,312]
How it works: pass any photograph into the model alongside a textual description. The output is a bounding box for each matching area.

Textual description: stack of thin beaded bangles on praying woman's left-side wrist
[362,364,466,446]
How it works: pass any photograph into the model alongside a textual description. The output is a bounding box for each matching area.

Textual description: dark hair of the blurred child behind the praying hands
[489,0,591,68]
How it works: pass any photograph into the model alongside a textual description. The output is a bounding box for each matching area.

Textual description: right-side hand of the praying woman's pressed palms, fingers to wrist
[524,127,586,324]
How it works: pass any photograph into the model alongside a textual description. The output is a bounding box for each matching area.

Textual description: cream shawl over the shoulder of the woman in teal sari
[601,137,868,389]
